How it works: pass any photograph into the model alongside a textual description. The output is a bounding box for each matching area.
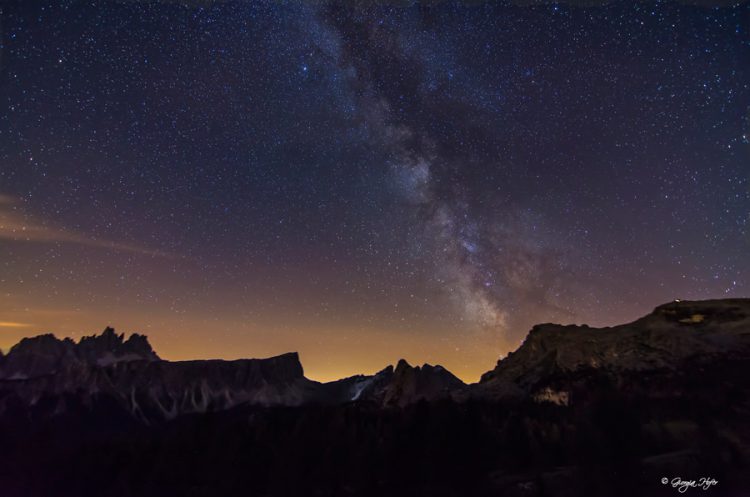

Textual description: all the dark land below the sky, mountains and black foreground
[0,299,750,496]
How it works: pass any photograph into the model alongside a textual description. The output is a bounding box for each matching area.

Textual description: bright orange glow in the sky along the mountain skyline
[0,304,517,382]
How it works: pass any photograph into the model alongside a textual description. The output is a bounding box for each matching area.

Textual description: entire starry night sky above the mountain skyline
[0,0,750,381]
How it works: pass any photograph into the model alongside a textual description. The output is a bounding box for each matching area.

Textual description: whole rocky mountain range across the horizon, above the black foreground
[0,299,750,423]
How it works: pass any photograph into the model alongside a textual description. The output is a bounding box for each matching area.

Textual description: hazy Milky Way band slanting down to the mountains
[326,2,580,334]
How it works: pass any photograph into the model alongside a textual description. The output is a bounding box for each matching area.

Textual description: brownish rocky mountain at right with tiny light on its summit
[475,299,750,402]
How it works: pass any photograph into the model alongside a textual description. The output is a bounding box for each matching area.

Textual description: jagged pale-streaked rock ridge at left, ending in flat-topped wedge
[0,328,318,422]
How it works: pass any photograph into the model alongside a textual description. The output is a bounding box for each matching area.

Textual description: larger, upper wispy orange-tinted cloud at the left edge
[0,194,174,257]
